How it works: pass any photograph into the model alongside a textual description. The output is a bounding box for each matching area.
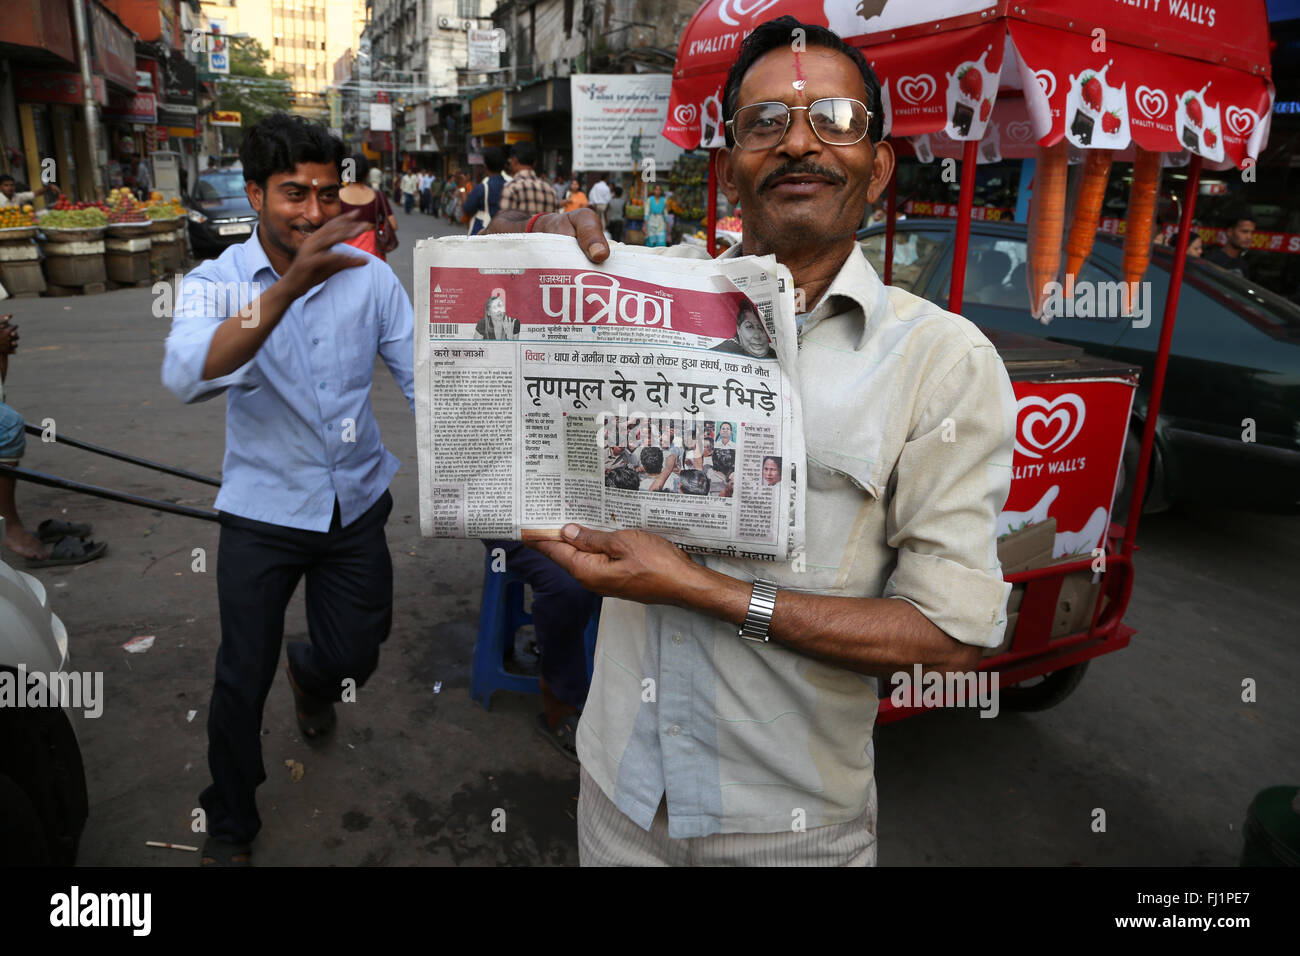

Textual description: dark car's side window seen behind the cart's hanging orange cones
[939,235,1121,323]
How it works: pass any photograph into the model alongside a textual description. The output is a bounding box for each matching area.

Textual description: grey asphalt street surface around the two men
[0,213,1300,868]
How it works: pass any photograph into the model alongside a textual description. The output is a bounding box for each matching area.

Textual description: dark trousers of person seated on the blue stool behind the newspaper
[484,540,595,710]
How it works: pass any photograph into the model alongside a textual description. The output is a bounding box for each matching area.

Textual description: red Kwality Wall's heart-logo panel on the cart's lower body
[997,377,1138,558]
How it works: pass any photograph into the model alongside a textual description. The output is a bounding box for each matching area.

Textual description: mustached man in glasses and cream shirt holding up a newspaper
[490,17,1015,865]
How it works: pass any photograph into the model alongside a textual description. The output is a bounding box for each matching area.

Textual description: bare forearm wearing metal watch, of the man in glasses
[683,567,980,678]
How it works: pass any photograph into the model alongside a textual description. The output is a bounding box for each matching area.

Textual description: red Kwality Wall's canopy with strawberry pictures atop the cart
[663,0,1273,168]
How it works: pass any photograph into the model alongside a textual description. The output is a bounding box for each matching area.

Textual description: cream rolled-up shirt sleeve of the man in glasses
[884,345,1015,648]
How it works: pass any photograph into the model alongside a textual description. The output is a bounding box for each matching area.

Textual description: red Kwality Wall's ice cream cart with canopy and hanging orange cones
[663,0,1274,723]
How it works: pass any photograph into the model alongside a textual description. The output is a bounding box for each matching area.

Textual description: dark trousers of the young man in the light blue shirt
[199,492,393,843]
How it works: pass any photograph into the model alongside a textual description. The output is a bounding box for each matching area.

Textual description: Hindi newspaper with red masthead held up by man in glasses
[415,235,806,561]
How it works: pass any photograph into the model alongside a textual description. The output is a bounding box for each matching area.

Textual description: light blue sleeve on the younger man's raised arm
[163,268,256,403]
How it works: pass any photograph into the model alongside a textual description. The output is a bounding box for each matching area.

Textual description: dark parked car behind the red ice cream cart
[858,219,1300,520]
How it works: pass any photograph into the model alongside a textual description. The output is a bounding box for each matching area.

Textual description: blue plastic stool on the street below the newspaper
[469,553,601,710]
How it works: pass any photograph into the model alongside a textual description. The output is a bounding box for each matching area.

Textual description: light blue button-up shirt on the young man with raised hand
[163,232,415,531]
